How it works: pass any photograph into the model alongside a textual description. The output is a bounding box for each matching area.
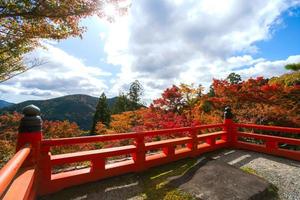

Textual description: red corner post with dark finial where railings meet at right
[222,106,237,147]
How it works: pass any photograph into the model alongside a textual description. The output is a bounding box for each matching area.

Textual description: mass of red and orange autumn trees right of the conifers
[111,72,300,132]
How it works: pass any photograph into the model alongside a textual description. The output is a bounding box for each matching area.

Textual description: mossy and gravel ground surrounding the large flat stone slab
[40,150,300,200]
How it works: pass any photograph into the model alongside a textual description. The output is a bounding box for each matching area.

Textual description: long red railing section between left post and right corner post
[40,124,227,194]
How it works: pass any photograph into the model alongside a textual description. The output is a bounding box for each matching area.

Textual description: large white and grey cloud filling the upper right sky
[101,0,300,99]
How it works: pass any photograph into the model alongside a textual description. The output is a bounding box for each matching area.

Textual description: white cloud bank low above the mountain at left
[0,42,111,98]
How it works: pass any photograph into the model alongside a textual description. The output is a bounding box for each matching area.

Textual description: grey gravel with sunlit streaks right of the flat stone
[210,150,300,200]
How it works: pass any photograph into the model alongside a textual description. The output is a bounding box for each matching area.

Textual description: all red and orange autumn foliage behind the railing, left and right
[0,72,300,167]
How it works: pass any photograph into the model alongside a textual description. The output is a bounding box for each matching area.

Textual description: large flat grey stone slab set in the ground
[170,159,276,200]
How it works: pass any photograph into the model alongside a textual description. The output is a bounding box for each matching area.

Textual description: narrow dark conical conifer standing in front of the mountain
[91,92,111,134]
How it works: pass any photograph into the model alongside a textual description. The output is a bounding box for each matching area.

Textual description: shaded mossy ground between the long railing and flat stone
[39,159,197,200]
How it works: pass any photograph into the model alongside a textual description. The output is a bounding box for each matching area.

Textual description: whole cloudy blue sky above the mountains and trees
[0,0,300,102]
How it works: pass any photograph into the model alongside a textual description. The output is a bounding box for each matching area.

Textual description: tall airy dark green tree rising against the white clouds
[128,80,144,110]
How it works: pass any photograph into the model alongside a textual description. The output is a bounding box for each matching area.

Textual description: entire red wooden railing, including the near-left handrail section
[0,105,300,199]
